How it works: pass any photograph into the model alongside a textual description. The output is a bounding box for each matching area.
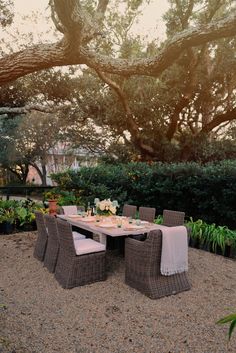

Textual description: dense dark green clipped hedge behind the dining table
[52,161,236,229]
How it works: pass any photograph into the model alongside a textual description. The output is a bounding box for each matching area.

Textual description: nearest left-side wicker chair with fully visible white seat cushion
[55,219,106,288]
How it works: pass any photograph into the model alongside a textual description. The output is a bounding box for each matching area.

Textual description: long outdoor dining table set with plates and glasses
[57,215,166,246]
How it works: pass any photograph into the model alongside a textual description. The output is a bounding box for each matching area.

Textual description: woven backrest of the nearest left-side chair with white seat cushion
[57,218,76,256]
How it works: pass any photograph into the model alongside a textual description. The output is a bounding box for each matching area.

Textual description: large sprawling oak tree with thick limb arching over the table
[0,0,236,159]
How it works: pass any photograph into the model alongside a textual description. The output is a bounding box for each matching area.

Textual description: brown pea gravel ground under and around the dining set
[0,233,236,353]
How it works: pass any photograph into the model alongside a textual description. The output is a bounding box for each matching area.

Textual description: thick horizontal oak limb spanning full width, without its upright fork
[0,11,236,85]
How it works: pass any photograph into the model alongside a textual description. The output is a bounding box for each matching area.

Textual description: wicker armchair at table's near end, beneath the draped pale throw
[125,230,190,299]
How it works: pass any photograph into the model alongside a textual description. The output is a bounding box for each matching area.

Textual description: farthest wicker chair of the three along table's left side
[34,211,48,261]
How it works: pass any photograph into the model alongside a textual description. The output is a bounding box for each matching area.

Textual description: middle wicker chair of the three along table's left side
[44,215,60,273]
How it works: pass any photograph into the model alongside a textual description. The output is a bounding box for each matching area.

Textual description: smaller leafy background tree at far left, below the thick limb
[0,111,67,185]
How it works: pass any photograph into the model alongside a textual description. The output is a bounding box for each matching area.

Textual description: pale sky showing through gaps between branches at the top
[14,0,168,39]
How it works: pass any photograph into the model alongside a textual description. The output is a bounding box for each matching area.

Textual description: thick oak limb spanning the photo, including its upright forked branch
[0,0,236,85]
